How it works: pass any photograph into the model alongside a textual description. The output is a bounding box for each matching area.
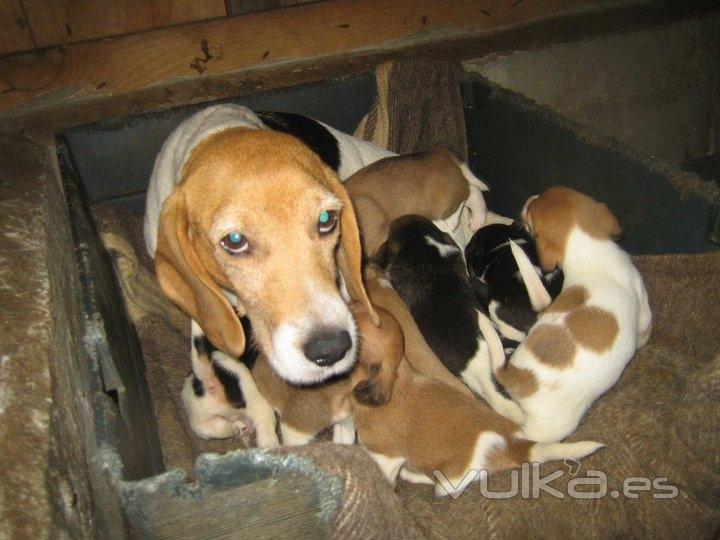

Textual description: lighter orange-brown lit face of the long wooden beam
[0,0,605,110]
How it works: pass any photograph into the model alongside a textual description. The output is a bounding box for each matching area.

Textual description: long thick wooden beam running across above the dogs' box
[0,0,716,131]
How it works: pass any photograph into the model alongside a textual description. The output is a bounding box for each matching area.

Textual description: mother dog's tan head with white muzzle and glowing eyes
[155,128,377,383]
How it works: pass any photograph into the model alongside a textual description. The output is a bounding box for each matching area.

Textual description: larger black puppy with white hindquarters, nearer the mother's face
[374,215,499,393]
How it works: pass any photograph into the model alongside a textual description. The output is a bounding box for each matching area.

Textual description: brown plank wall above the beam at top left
[0,0,312,55]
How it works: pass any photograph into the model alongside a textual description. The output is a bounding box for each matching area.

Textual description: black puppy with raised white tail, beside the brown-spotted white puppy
[465,221,563,342]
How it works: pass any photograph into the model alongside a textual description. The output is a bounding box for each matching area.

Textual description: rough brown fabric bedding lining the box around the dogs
[94,60,720,538]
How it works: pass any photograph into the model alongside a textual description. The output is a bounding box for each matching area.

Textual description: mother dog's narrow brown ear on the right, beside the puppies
[321,165,380,326]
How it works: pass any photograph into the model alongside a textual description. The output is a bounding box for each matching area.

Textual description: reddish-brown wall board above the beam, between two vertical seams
[22,0,226,48]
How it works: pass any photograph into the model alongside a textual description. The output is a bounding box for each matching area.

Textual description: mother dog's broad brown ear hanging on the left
[155,190,245,357]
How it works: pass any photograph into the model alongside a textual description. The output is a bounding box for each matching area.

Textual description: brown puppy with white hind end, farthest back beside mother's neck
[345,147,488,256]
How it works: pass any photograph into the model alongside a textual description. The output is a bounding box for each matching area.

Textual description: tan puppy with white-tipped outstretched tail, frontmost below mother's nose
[350,305,602,496]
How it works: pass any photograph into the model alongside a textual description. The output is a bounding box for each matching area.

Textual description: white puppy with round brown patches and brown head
[484,187,652,441]
